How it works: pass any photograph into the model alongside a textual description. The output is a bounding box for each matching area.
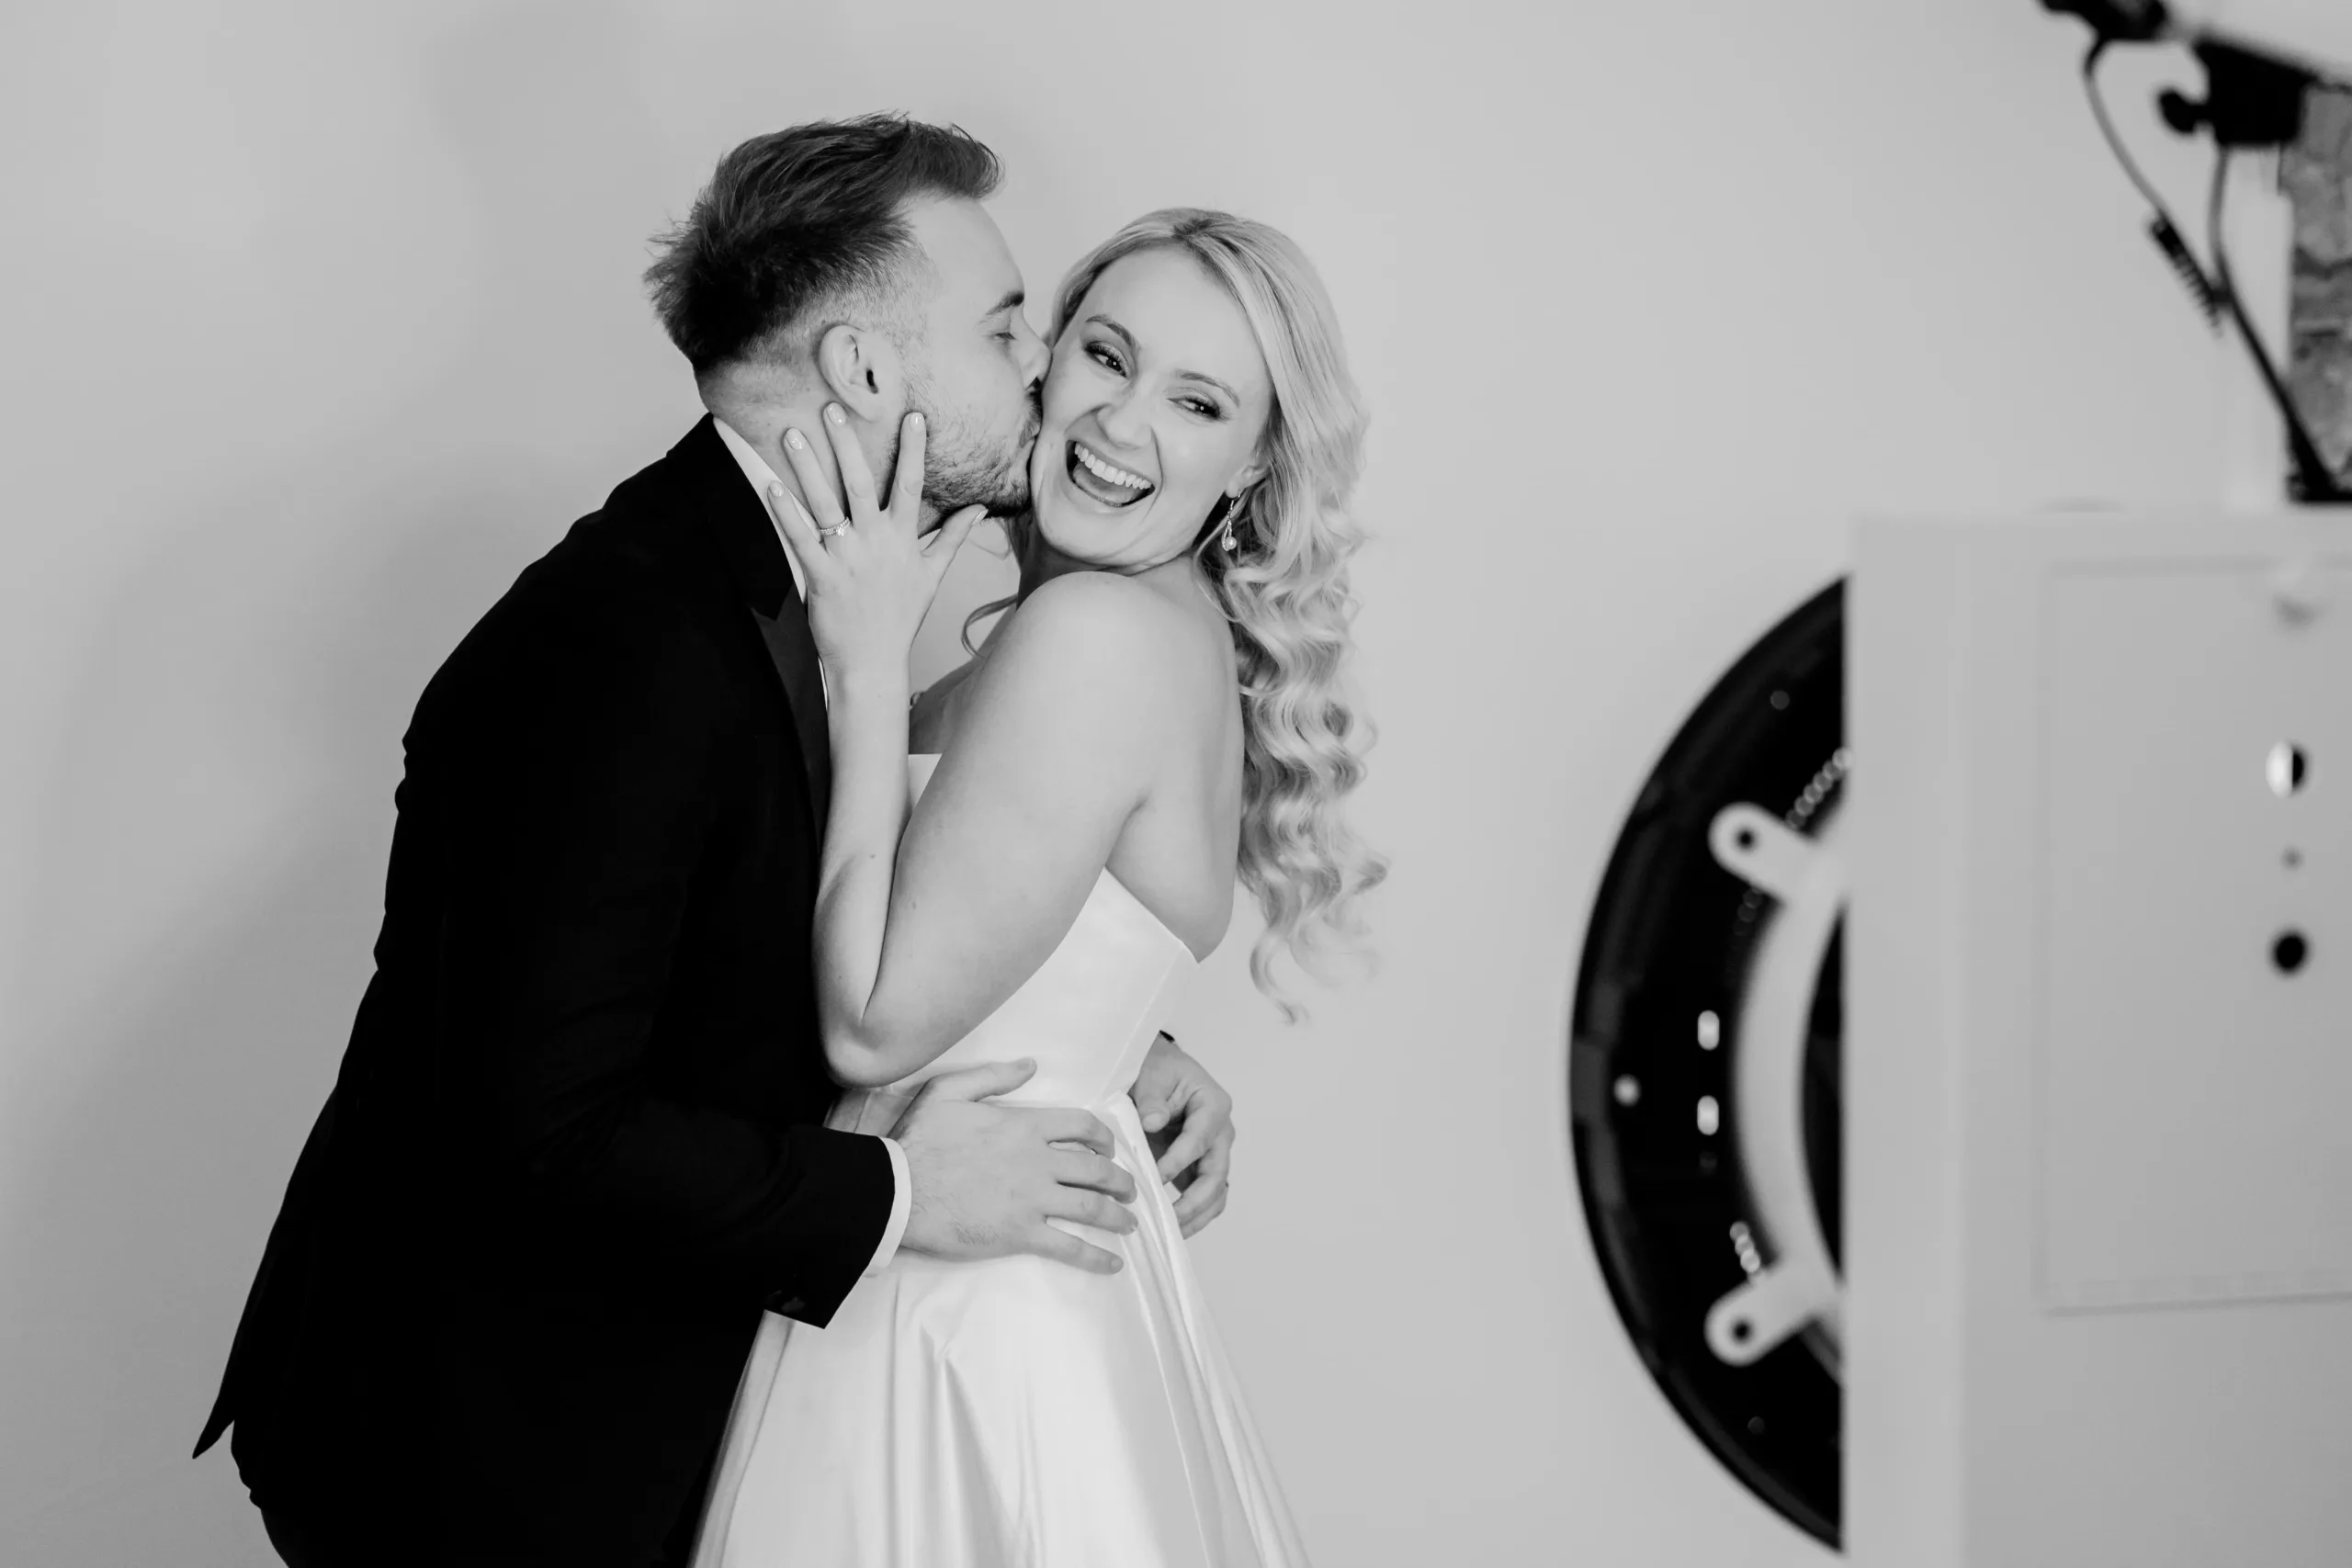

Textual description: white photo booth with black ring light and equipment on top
[1569,5,2352,1568]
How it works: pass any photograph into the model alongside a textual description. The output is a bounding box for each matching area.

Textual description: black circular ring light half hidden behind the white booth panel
[1569,581,1849,1547]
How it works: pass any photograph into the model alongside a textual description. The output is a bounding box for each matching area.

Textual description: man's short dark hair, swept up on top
[644,115,1002,376]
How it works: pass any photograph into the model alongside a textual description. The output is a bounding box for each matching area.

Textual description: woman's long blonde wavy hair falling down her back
[976,207,1387,1022]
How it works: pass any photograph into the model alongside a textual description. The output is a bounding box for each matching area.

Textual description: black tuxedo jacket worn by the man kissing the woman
[198,419,891,1568]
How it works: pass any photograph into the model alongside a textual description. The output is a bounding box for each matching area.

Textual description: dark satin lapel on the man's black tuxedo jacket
[668,413,832,837]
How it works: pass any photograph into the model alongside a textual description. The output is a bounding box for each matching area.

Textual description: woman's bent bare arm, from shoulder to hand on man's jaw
[786,411,1183,1086]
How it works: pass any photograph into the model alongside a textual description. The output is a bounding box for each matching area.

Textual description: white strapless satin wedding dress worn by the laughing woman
[694,757,1307,1568]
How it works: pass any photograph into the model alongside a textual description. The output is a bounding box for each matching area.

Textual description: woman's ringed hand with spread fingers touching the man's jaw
[769,404,986,682]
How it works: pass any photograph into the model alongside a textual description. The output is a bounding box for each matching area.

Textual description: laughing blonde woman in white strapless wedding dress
[696,209,1385,1568]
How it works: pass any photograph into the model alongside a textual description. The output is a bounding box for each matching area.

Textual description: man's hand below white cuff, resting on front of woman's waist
[889,1063,1136,1274]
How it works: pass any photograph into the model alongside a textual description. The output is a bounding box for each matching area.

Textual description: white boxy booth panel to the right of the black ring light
[1844,510,2352,1568]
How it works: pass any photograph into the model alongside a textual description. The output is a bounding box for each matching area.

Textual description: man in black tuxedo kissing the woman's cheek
[198,115,1232,1568]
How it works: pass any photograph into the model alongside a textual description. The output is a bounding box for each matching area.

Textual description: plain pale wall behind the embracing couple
[0,0,2218,1568]
